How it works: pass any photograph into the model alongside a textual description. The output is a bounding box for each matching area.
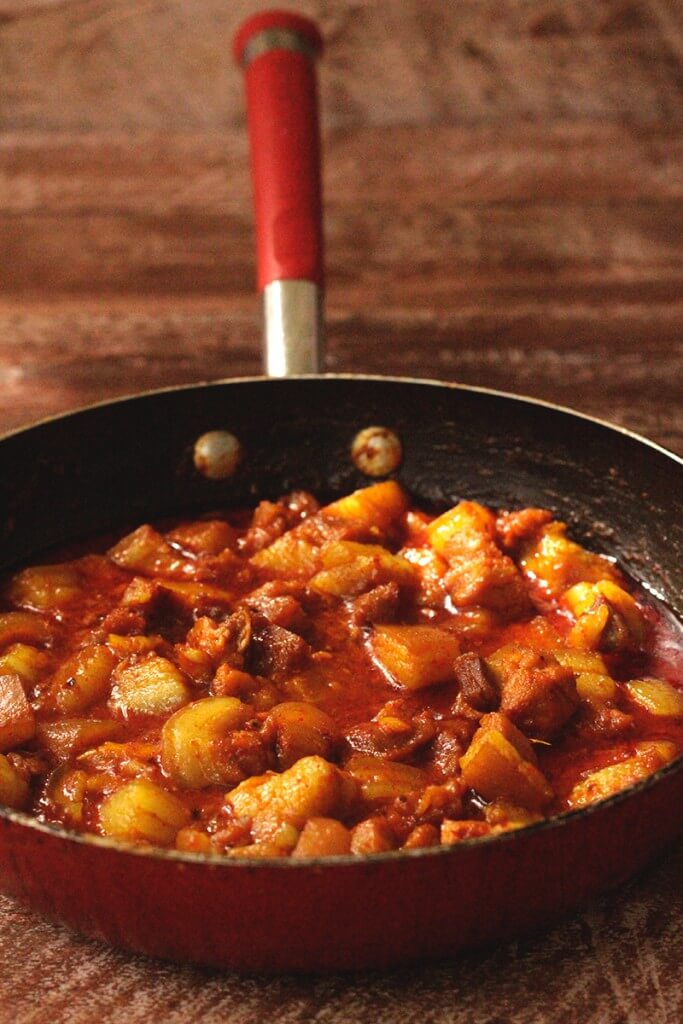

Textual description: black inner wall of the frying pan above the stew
[0,377,683,615]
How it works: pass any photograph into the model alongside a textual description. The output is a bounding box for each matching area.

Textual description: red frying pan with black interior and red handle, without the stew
[0,12,683,972]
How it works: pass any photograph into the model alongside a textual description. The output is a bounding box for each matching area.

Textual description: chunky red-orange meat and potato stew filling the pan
[0,481,683,857]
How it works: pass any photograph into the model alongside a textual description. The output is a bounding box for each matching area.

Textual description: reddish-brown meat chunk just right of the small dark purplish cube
[488,644,580,739]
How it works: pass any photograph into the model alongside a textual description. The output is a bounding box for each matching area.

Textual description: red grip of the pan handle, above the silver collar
[234,11,323,291]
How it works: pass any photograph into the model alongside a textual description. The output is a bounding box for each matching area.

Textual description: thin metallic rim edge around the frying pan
[0,373,683,871]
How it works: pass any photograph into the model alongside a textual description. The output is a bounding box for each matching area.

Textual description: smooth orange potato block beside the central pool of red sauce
[370,626,460,690]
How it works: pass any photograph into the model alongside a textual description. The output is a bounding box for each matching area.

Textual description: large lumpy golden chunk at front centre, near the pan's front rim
[225,756,346,841]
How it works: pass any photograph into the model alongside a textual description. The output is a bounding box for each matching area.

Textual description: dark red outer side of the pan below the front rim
[0,766,683,972]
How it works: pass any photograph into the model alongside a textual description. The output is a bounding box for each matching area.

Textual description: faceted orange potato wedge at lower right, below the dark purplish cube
[460,713,553,811]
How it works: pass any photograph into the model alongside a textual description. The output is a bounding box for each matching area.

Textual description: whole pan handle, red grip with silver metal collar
[233,10,323,377]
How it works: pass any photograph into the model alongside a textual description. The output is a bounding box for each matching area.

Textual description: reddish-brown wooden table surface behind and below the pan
[0,0,683,1024]
